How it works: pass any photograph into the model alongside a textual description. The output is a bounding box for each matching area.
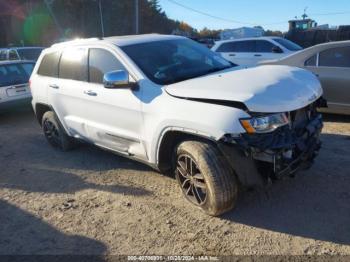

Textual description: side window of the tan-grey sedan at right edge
[319,47,350,67]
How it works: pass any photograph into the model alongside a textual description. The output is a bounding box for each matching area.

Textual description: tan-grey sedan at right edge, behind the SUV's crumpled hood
[261,41,350,114]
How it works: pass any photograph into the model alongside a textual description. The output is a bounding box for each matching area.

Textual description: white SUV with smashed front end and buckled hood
[31,35,322,215]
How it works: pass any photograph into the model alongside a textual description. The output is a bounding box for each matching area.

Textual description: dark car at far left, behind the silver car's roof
[0,47,44,61]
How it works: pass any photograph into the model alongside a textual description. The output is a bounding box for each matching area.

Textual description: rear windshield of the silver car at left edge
[0,63,34,87]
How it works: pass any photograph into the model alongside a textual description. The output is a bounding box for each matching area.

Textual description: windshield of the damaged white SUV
[121,39,235,85]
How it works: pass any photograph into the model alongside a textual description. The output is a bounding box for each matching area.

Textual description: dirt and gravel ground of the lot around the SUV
[0,107,350,255]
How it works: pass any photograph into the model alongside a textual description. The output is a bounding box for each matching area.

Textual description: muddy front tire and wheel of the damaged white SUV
[175,141,238,216]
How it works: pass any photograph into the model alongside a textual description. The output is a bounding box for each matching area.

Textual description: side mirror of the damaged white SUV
[103,70,137,89]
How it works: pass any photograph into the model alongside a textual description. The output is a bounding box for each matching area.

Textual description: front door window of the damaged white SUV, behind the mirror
[89,48,125,84]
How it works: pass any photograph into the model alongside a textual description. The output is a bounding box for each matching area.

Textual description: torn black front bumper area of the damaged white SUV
[219,110,323,187]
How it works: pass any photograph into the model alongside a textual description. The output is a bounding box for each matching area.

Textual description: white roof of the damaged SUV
[52,34,184,47]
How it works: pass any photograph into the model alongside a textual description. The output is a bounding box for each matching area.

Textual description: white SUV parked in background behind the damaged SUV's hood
[212,37,302,66]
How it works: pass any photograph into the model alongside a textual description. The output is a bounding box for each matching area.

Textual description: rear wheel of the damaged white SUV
[41,111,75,151]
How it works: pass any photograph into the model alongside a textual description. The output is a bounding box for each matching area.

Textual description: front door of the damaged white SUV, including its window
[83,48,146,158]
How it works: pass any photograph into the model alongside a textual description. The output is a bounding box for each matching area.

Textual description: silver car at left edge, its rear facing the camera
[0,61,35,112]
